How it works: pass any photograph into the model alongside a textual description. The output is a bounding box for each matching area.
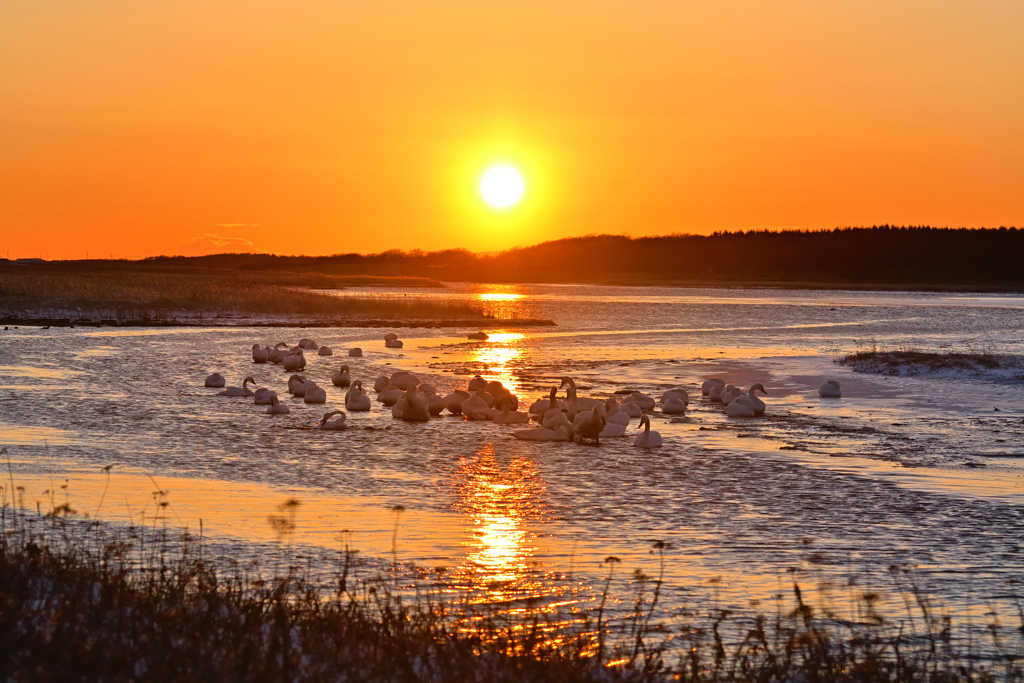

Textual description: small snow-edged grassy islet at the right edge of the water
[834,339,1024,379]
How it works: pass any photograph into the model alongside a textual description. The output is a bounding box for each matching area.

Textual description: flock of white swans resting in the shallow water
[204,333,842,449]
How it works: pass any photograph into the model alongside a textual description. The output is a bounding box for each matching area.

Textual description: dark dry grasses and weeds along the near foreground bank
[0,464,1024,683]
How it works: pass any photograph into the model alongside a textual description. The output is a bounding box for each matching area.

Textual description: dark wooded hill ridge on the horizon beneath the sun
[125,225,1024,289]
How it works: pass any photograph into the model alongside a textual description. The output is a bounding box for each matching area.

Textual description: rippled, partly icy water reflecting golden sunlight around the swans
[0,286,1024,643]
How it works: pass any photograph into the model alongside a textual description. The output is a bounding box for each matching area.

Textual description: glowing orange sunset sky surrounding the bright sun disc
[0,0,1024,258]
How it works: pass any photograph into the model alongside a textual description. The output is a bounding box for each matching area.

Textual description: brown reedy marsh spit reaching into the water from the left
[0,266,484,321]
